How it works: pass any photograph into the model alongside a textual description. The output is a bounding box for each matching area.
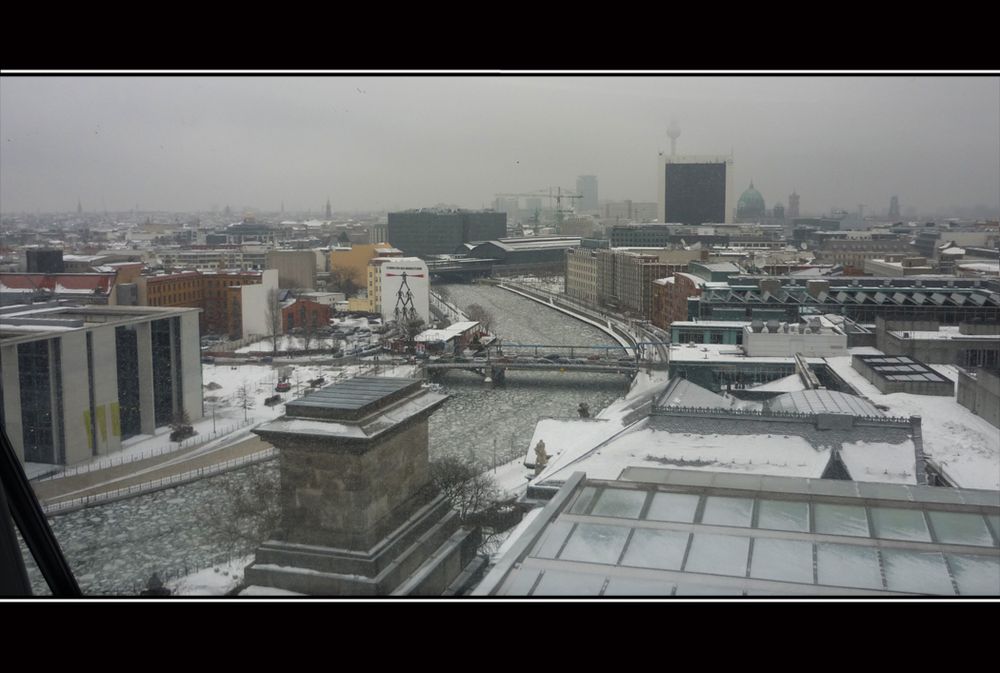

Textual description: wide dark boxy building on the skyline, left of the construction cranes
[388,209,507,257]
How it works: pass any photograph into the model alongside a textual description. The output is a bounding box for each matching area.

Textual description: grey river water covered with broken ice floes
[29,284,628,596]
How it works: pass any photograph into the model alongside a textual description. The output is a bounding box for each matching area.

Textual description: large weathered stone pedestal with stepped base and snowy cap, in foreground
[245,378,478,596]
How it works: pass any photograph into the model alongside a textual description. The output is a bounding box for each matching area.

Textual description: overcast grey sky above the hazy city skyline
[0,75,1000,218]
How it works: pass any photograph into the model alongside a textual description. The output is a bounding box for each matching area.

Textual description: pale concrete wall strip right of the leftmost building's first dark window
[53,330,93,465]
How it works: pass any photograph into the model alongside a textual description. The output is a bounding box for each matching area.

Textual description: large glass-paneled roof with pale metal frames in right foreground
[476,468,1000,597]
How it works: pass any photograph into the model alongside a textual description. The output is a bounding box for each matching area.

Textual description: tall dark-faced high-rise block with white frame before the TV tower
[657,155,735,224]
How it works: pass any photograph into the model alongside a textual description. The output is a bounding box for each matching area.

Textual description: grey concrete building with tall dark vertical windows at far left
[0,306,203,465]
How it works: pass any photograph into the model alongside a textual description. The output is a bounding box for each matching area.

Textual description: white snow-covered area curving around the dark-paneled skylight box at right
[826,351,1000,490]
